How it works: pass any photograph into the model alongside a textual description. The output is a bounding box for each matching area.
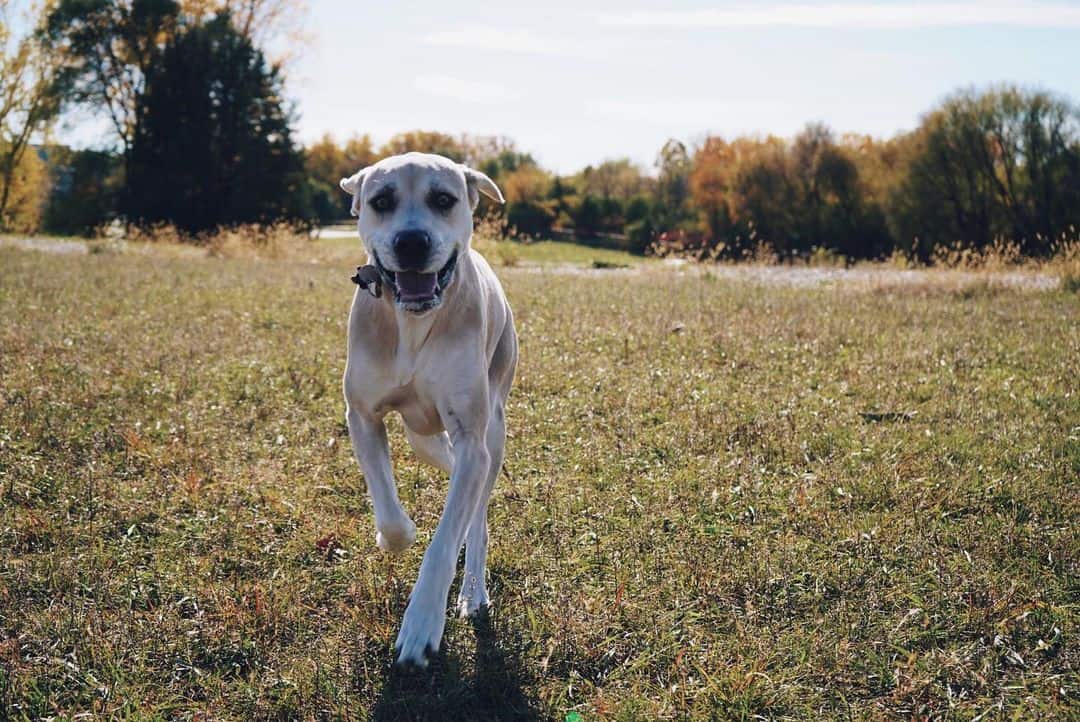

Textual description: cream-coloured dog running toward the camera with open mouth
[340,153,517,667]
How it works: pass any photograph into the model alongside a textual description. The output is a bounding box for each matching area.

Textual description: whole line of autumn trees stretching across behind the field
[0,0,1080,259]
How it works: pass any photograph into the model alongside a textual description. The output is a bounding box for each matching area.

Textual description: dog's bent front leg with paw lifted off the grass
[346,408,416,553]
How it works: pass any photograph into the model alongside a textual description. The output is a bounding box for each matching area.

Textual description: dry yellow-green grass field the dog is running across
[0,239,1080,721]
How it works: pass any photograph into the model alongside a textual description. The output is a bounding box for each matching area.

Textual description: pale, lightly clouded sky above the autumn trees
[56,0,1080,173]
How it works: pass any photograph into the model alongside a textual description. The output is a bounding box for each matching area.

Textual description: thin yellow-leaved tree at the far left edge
[0,0,59,230]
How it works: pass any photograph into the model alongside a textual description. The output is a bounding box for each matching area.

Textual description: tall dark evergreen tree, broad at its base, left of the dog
[123,15,311,232]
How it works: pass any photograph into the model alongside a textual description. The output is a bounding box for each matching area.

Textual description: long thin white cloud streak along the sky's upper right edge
[599,2,1080,29]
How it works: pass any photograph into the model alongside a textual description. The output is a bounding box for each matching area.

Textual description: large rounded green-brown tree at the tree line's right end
[892,86,1080,255]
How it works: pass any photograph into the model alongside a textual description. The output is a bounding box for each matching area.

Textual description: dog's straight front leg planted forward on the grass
[394,389,491,666]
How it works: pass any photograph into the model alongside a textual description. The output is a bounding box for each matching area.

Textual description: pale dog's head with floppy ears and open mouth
[340,153,502,313]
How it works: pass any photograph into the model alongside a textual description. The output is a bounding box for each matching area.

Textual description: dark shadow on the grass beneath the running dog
[372,612,544,721]
